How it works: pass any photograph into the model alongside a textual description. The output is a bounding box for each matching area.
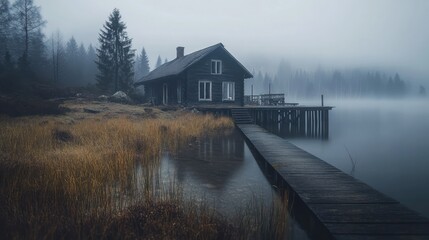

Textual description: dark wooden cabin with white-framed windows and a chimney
[135,43,253,106]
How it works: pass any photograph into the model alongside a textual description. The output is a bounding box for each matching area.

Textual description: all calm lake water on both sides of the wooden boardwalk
[157,99,429,239]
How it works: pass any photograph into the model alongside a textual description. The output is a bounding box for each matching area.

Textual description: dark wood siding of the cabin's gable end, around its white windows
[186,49,244,105]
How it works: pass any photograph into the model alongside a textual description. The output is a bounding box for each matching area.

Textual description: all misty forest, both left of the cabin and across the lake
[0,0,426,99]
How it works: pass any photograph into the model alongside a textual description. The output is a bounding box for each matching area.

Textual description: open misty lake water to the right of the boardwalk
[290,99,429,217]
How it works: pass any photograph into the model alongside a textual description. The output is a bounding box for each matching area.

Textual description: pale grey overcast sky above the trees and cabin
[34,0,429,76]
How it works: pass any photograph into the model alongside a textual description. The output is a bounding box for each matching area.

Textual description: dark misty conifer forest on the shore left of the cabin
[0,0,157,97]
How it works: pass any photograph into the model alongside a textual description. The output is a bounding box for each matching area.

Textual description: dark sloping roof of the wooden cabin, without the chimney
[135,43,253,85]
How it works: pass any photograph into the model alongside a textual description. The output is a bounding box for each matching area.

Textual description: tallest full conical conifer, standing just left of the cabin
[96,8,134,92]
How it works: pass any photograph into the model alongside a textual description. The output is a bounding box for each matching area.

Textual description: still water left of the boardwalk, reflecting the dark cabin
[161,130,308,239]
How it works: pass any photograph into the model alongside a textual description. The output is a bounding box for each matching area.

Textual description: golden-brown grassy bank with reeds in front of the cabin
[0,101,286,239]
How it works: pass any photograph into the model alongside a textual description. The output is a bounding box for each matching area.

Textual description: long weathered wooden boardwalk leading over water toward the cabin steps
[237,124,429,240]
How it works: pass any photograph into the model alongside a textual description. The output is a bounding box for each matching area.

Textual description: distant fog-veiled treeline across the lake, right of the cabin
[245,60,426,99]
